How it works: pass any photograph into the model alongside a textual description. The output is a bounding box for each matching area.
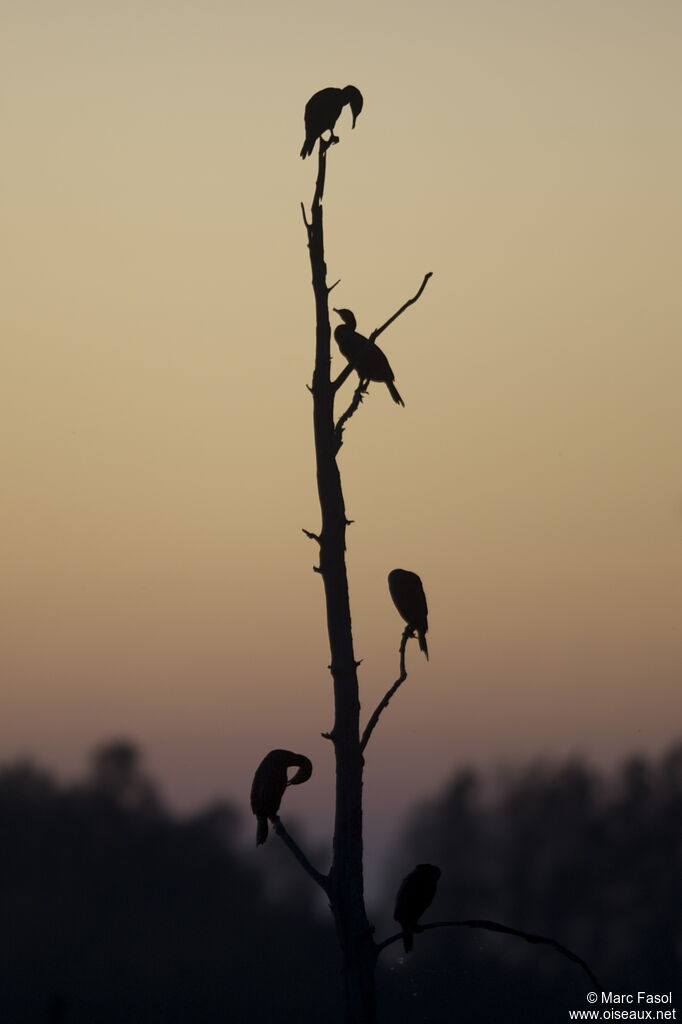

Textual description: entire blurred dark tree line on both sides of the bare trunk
[0,741,682,1024]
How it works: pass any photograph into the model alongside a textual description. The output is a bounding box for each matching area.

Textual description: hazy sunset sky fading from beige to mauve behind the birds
[5,0,682,880]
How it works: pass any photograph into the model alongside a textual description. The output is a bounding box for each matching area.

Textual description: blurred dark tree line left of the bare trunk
[0,742,338,1024]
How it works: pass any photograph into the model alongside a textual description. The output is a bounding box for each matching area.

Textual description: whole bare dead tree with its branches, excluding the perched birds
[250,112,600,1024]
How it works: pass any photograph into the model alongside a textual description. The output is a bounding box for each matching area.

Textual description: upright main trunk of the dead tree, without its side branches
[306,146,377,1024]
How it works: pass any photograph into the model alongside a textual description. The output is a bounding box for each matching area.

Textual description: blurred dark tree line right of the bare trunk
[384,744,682,1024]
